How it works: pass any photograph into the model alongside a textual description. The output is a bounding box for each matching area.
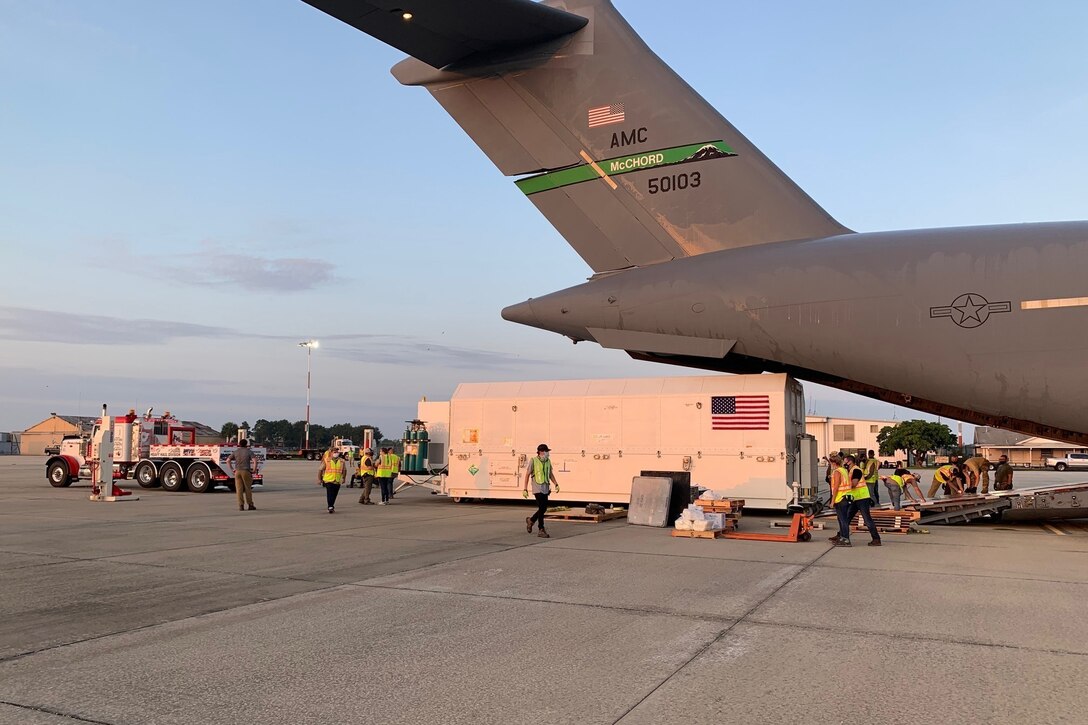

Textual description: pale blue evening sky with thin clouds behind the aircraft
[0,0,1088,433]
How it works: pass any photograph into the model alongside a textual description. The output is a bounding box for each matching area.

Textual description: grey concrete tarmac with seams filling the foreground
[0,457,1088,725]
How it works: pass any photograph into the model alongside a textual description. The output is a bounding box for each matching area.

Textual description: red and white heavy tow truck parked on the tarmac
[46,410,265,493]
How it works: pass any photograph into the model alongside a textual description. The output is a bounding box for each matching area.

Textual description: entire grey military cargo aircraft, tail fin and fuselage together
[305,0,1088,444]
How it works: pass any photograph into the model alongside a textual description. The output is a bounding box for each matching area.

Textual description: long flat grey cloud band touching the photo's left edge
[0,306,236,345]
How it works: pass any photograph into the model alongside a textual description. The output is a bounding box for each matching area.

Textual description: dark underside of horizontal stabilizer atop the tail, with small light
[302,0,588,67]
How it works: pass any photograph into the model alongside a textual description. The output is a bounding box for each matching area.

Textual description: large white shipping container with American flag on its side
[418,374,828,509]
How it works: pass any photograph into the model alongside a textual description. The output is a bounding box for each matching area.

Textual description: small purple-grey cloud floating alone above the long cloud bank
[90,241,336,294]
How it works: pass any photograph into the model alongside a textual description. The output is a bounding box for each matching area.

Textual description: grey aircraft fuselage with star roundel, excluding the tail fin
[503,222,1088,443]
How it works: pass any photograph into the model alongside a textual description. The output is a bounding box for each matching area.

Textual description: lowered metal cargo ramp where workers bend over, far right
[917,483,1088,526]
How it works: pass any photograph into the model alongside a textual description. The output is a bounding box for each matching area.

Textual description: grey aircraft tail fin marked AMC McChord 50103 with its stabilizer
[306,0,850,273]
